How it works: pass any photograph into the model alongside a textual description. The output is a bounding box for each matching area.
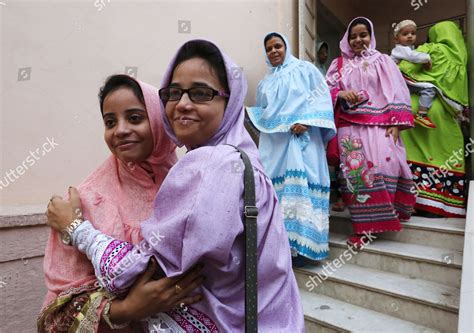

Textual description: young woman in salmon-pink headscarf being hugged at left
[38,75,203,332]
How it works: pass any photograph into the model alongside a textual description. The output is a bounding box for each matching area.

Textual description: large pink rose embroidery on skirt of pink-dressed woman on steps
[340,135,376,203]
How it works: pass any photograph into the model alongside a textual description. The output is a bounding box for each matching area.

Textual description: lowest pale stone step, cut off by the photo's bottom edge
[300,290,438,333]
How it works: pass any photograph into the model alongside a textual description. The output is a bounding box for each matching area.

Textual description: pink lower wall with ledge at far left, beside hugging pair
[0,214,49,333]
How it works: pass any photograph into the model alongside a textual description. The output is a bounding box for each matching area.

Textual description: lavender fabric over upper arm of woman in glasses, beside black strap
[142,145,243,276]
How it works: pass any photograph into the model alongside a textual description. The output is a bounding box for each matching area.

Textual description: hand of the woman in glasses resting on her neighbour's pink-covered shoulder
[46,187,82,231]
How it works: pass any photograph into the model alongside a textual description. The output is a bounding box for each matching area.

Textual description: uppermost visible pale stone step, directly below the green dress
[330,209,466,251]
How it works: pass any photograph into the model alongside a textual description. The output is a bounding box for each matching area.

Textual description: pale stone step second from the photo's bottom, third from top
[295,263,459,332]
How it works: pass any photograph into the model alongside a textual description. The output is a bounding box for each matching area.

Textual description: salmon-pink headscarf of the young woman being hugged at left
[43,81,176,306]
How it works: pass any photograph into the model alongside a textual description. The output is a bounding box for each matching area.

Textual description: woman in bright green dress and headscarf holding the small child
[399,21,470,217]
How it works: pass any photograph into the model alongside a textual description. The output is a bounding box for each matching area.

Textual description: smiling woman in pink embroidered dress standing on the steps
[326,17,415,246]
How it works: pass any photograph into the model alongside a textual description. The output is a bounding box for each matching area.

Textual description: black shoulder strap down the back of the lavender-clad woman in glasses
[229,145,258,333]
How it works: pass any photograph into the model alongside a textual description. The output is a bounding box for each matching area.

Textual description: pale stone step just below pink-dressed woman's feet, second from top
[329,233,462,288]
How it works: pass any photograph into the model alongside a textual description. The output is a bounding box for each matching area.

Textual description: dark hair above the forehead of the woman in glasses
[173,40,229,92]
